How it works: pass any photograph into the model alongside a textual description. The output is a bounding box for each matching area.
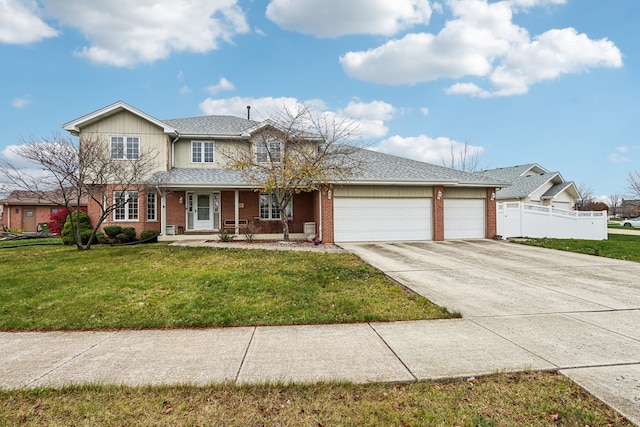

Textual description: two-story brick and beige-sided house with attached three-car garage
[63,102,509,243]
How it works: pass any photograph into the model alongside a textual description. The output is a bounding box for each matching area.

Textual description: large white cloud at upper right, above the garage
[340,0,622,97]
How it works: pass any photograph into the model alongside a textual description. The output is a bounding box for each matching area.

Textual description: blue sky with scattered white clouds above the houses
[0,0,640,201]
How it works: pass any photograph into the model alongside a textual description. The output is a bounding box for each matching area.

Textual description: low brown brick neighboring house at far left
[0,190,87,233]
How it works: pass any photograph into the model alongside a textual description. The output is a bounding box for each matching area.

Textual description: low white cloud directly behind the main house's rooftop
[199,97,396,138]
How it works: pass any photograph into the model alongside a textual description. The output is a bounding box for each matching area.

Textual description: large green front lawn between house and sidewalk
[0,244,452,330]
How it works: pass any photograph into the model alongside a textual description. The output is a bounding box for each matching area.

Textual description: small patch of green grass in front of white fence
[518,234,640,262]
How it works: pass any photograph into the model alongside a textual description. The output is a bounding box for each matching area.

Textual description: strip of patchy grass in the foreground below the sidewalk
[0,372,632,427]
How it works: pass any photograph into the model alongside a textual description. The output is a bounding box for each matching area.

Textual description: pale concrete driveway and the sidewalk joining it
[0,241,640,425]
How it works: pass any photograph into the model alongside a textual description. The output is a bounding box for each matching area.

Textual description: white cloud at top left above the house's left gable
[42,0,249,67]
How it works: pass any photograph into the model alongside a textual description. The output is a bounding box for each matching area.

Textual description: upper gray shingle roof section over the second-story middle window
[163,116,258,136]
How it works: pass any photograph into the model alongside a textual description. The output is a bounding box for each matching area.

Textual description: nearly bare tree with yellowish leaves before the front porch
[223,106,362,241]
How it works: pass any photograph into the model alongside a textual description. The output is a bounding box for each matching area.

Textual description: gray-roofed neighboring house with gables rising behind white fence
[480,163,580,210]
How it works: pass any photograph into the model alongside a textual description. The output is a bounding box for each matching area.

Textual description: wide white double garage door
[333,197,431,242]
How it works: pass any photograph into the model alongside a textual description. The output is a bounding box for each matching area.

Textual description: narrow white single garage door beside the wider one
[444,199,486,240]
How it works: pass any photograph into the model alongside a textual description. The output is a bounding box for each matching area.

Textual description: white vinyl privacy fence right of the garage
[497,202,607,240]
